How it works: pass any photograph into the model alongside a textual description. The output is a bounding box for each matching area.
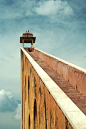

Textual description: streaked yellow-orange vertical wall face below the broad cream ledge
[21,50,72,129]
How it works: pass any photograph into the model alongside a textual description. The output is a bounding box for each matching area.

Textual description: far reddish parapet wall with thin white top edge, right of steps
[34,49,86,96]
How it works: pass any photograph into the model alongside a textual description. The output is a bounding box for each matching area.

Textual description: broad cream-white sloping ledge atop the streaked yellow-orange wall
[21,48,86,129]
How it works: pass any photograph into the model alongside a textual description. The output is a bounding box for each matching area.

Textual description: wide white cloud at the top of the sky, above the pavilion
[34,0,73,15]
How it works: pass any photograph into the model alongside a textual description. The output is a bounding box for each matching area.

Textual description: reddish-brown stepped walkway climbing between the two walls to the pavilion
[26,50,86,115]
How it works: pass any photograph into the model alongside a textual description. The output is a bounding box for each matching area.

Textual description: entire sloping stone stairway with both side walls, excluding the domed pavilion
[21,31,86,129]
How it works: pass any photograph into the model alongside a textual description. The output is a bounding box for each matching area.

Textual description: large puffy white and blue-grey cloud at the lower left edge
[0,90,18,112]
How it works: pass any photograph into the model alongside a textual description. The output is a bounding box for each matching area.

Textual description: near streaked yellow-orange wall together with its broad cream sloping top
[21,48,86,129]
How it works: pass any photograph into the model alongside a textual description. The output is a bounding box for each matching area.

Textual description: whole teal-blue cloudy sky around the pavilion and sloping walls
[0,0,86,129]
